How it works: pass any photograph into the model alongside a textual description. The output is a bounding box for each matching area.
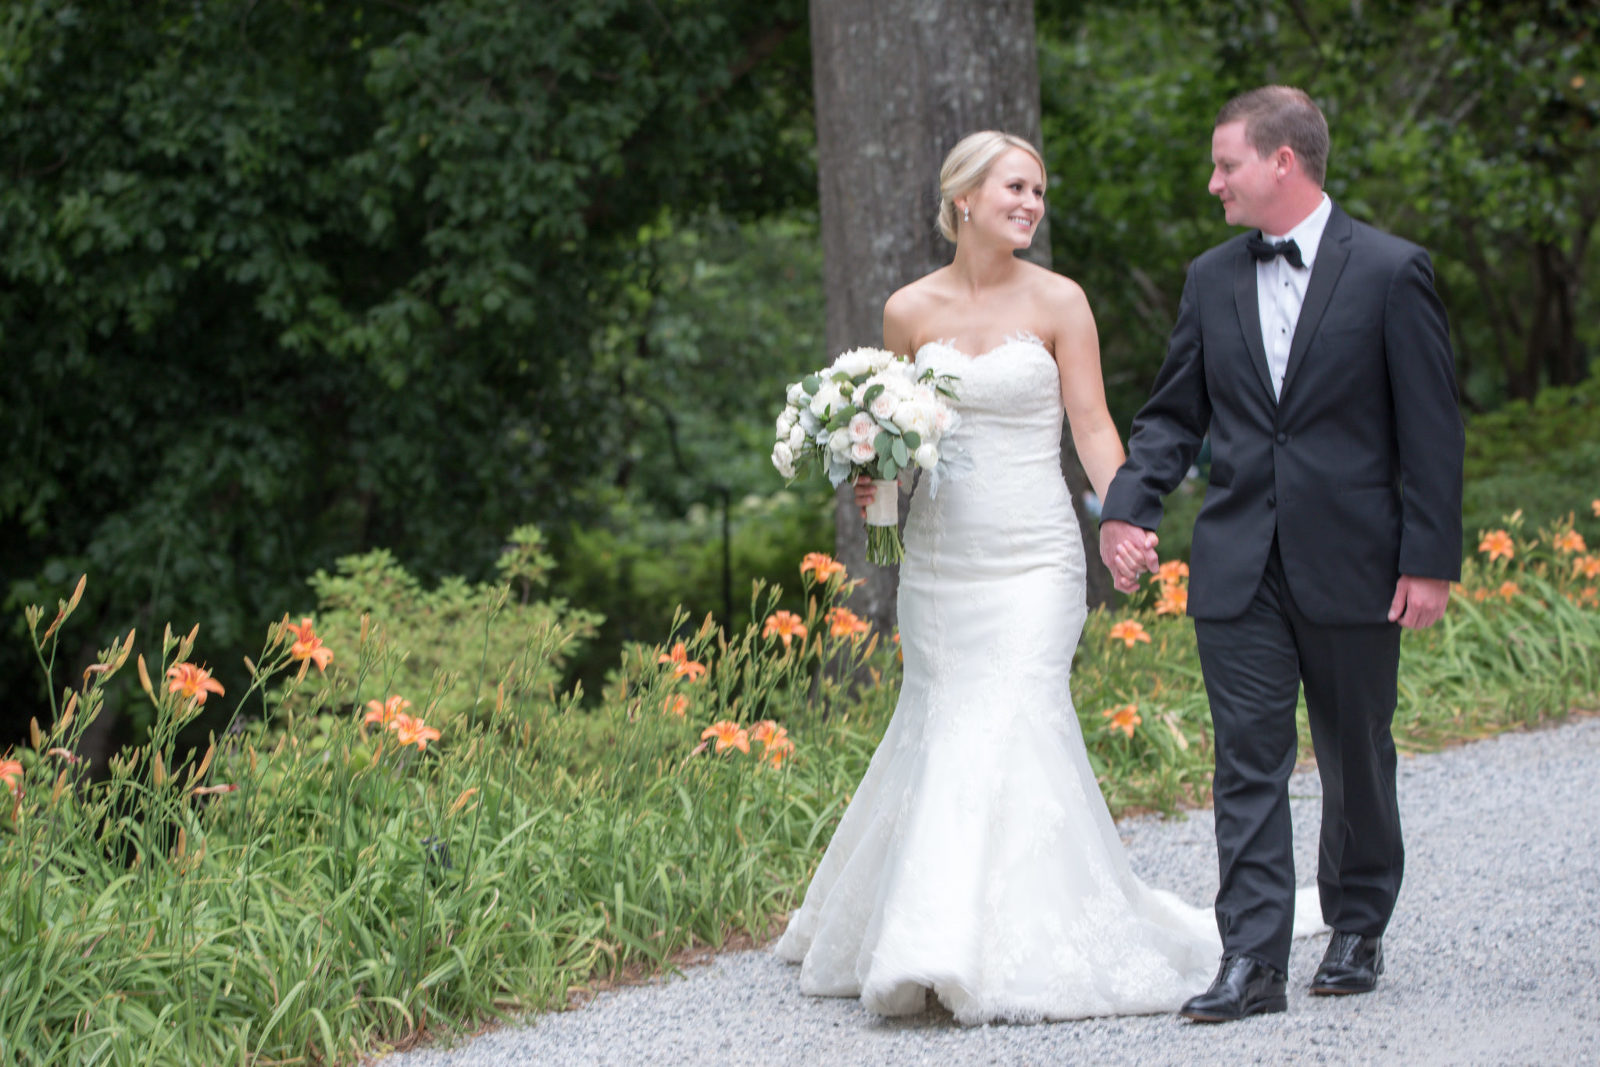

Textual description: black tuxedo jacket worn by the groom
[1102,205,1464,624]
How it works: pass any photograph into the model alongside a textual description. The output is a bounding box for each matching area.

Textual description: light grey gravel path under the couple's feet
[381,718,1600,1067]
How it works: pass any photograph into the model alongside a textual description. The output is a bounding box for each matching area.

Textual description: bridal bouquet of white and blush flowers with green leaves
[773,349,971,565]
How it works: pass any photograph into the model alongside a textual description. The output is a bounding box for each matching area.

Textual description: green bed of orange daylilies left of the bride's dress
[0,556,893,1065]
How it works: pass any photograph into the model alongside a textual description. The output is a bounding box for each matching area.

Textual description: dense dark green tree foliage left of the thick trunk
[0,0,814,742]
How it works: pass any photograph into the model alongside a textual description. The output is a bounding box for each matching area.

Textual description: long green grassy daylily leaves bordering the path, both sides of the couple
[0,499,1600,1065]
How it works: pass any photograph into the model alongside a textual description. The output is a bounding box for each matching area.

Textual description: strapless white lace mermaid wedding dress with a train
[776,338,1317,1024]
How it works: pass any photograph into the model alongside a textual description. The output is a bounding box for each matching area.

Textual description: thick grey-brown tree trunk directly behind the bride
[811,0,1099,630]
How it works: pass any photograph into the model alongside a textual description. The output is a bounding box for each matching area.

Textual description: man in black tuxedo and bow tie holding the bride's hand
[1101,85,1462,1022]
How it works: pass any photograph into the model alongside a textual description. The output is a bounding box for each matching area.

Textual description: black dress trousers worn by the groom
[1195,539,1405,971]
